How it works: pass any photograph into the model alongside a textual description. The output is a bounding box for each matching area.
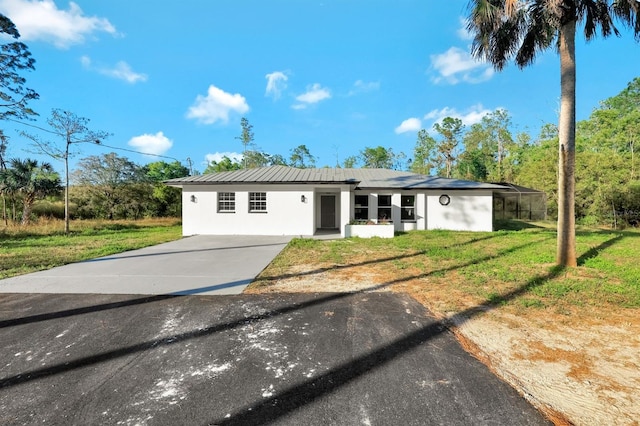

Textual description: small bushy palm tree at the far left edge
[4,158,62,225]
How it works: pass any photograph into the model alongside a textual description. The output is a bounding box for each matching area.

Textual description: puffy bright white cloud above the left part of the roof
[187,85,249,124]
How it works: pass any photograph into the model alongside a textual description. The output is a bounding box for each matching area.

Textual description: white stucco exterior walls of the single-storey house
[182,185,493,236]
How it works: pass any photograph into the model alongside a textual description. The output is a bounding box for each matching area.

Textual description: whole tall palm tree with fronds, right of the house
[468,0,640,266]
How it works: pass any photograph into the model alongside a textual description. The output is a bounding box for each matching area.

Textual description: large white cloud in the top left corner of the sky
[0,0,117,49]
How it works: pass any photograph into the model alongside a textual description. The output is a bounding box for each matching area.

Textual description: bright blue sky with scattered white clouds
[0,0,640,171]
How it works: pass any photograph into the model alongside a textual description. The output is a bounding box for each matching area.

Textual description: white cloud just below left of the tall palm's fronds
[431,47,493,84]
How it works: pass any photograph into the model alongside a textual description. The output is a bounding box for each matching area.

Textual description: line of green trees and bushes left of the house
[0,152,189,224]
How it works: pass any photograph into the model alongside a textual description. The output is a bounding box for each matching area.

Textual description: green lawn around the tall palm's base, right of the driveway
[253,223,640,312]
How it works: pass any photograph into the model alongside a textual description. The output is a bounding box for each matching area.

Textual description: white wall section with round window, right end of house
[426,190,493,232]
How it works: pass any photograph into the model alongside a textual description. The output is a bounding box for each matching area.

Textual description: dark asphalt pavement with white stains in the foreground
[0,293,550,426]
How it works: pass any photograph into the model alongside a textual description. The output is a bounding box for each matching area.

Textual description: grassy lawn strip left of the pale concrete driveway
[0,219,182,279]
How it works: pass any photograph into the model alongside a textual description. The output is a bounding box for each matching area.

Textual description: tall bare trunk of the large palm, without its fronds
[556,18,577,266]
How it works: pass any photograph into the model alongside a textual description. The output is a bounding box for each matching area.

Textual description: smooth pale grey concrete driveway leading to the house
[0,235,291,295]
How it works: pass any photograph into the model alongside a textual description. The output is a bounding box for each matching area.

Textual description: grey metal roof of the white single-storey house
[165,166,505,190]
